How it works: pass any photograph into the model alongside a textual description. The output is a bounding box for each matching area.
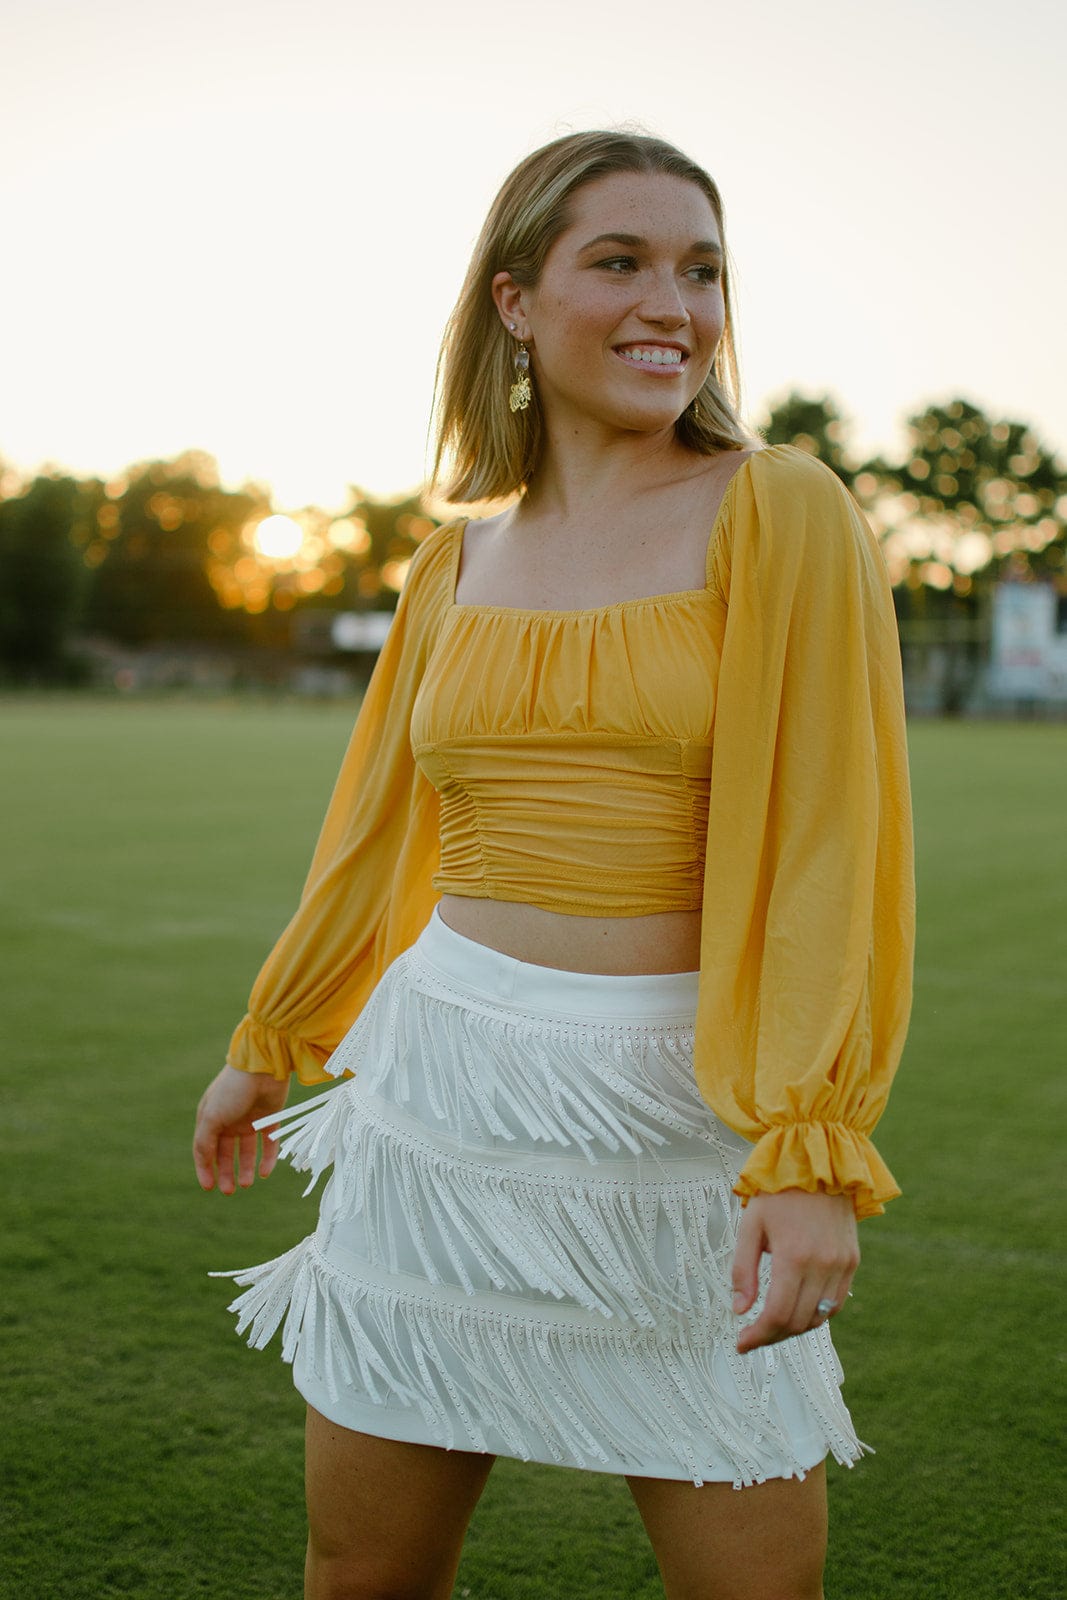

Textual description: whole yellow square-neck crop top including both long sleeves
[227,445,915,1216]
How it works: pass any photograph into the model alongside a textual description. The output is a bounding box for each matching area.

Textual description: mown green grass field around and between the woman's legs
[0,699,1067,1600]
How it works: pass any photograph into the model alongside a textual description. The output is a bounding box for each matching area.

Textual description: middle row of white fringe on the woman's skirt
[331,1102,733,1338]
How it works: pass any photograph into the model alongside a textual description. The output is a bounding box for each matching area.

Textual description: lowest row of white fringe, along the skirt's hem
[213,1237,865,1488]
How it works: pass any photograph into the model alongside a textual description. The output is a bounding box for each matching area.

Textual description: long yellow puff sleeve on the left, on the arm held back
[227,523,454,1083]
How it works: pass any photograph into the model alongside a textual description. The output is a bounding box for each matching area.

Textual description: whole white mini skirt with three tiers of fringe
[219,910,865,1488]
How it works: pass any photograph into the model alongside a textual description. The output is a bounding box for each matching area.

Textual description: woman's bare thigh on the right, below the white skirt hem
[627,1464,827,1600]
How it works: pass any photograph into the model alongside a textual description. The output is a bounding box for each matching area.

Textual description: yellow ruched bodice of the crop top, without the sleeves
[411,590,717,917]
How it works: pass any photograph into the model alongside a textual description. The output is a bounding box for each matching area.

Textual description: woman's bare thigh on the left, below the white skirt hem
[306,1406,496,1600]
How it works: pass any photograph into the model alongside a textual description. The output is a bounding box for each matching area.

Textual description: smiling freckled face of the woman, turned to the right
[494,173,725,432]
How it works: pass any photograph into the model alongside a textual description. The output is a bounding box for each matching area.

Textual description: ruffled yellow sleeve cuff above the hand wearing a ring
[734,1122,901,1218]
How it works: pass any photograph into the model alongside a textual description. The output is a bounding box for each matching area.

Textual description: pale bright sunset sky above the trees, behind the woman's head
[0,0,1067,510]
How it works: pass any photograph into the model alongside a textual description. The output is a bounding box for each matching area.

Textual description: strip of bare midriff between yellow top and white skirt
[438,894,701,976]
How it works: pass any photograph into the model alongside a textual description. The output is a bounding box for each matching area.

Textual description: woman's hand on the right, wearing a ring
[733,1189,859,1354]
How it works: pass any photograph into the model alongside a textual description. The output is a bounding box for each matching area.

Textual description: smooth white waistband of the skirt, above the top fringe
[413,906,701,1022]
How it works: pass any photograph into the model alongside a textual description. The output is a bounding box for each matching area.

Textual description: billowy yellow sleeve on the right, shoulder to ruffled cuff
[694,446,915,1218]
